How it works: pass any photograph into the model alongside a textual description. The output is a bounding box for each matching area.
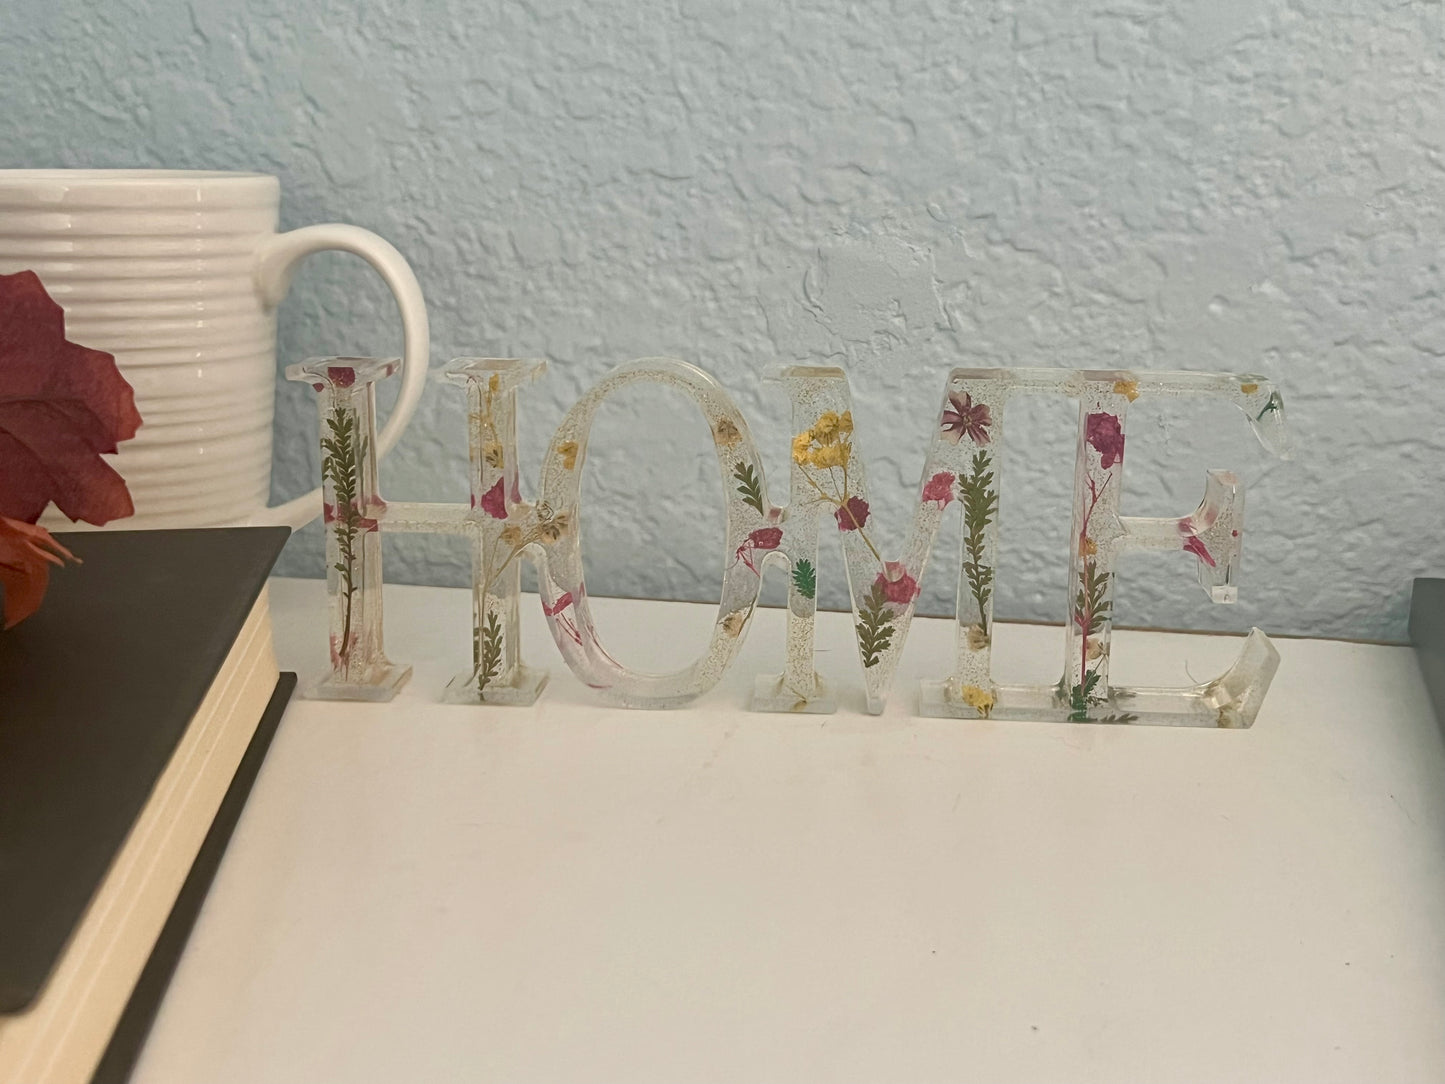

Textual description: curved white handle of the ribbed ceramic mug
[246,223,431,530]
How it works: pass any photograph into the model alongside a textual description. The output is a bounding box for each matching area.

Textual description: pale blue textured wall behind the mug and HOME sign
[0,0,1445,637]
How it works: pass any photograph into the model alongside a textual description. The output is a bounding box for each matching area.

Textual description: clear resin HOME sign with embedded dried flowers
[288,357,1286,727]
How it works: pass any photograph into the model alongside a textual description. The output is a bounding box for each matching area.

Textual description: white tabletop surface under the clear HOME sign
[133,581,1445,1084]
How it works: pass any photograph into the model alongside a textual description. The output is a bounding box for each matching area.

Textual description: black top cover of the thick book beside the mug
[0,528,289,1038]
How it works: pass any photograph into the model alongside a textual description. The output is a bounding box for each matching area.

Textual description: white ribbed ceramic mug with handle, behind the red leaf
[0,169,428,529]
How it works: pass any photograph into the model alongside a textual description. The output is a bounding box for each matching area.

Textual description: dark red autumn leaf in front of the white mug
[0,272,140,526]
